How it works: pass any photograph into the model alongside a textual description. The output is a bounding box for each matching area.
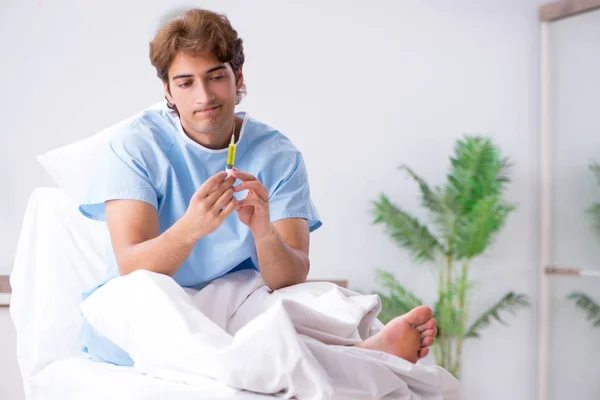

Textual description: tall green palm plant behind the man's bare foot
[372,136,529,377]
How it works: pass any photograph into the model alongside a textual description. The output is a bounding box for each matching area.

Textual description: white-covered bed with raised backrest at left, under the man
[10,188,272,400]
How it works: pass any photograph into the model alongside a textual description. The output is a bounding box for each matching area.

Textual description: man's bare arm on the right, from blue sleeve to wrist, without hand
[254,218,310,290]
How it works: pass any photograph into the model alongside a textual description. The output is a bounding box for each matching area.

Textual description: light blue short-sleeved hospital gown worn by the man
[79,108,321,365]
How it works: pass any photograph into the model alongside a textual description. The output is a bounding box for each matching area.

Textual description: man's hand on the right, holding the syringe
[231,168,273,239]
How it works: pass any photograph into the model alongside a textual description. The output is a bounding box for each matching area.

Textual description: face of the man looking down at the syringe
[165,52,243,137]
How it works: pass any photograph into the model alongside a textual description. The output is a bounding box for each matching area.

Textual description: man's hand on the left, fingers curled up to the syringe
[183,171,236,241]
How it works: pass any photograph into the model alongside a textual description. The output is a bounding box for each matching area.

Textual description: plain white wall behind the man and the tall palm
[0,0,540,400]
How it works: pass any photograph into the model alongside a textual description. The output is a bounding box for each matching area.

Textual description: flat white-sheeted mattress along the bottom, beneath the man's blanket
[30,358,276,400]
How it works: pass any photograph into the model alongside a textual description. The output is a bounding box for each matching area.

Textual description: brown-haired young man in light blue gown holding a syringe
[80,9,436,365]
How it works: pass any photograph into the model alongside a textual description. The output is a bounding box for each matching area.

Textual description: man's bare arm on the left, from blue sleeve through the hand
[106,172,236,276]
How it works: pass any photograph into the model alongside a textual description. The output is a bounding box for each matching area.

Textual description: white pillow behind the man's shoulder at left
[37,100,168,204]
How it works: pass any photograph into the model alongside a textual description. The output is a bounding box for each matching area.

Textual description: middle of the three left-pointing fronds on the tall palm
[373,194,440,262]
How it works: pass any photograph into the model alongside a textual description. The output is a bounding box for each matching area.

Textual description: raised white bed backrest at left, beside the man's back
[10,188,110,390]
